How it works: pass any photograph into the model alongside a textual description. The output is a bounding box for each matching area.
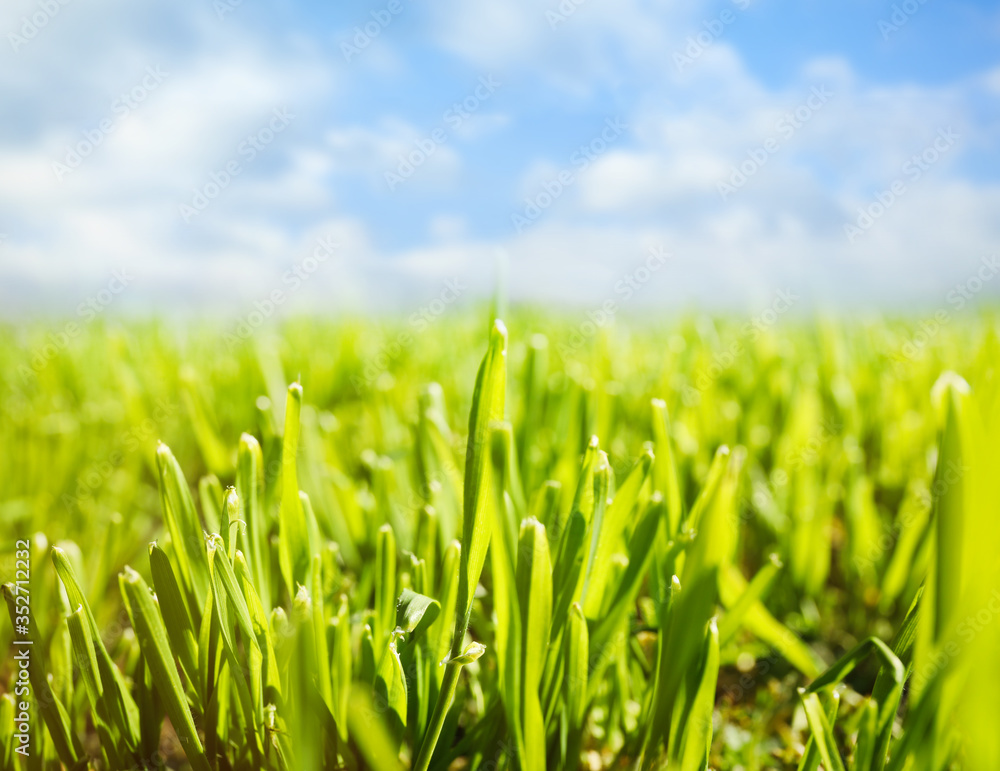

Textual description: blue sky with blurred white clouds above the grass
[0,0,1000,316]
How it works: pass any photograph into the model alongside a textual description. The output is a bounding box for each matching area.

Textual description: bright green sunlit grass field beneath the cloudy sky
[0,309,1000,771]
